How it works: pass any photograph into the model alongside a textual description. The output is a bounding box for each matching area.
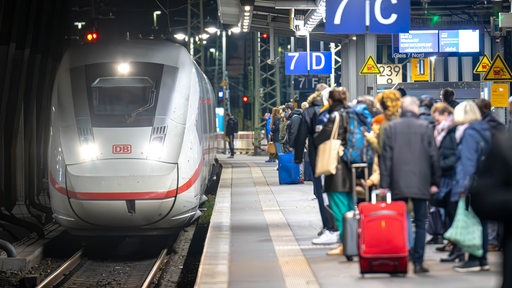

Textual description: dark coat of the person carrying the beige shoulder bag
[314,103,352,192]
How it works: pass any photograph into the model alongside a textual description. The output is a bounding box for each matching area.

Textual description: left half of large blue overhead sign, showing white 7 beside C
[325,0,366,34]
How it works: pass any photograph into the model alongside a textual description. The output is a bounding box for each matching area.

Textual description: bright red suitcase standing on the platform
[358,191,409,276]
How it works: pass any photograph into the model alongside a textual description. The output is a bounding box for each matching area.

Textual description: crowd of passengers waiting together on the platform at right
[265,84,512,287]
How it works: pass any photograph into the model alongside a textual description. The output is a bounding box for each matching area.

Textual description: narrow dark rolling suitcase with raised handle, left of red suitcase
[342,163,368,261]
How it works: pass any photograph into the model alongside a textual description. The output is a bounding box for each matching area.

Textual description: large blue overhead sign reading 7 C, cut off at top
[325,0,411,34]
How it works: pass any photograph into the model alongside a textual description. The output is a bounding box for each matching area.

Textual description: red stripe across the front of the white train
[50,163,202,200]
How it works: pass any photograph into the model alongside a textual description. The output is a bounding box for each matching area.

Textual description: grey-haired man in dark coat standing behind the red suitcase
[379,96,440,273]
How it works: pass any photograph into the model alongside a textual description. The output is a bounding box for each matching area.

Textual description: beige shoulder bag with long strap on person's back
[315,113,343,177]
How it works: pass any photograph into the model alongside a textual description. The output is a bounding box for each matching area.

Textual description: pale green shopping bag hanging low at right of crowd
[444,197,484,257]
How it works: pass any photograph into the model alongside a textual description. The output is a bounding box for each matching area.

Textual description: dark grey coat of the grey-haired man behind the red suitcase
[379,112,440,200]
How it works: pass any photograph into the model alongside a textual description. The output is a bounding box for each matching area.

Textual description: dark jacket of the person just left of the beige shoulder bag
[294,98,323,163]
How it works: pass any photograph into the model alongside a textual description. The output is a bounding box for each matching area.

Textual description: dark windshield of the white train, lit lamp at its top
[80,62,164,127]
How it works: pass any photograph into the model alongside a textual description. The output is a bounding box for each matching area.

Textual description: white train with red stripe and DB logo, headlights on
[48,40,216,234]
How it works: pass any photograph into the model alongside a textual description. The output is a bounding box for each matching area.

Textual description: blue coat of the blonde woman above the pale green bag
[450,121,491,201]
